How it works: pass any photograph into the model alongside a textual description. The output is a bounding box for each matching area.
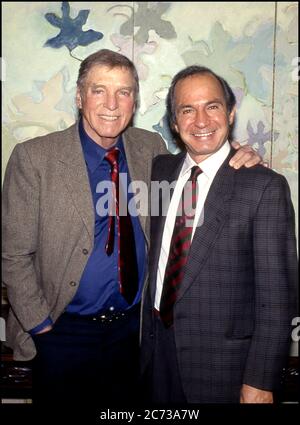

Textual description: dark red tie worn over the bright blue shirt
[105,148,138,304]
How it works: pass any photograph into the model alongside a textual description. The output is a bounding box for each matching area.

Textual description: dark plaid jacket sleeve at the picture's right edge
[244,174,297,390]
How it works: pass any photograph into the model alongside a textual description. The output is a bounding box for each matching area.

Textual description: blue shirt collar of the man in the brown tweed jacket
[79,119,125,173]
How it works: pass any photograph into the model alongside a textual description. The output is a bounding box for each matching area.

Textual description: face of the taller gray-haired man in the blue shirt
[76,65,135,149]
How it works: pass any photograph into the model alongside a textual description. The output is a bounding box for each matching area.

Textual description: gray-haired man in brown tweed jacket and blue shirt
[3,49,260,404]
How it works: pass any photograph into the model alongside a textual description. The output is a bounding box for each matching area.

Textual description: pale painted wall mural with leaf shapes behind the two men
[2,2,299,232]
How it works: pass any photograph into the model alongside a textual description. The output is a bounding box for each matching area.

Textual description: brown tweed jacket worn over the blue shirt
[3,123,167,360]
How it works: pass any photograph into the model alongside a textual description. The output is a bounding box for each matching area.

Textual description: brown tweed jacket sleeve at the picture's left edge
[2,143,49,331]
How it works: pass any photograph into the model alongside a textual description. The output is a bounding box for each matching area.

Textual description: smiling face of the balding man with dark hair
[175,74,235,163]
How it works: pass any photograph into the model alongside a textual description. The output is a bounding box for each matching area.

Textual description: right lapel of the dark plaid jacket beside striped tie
[177,153,235,301]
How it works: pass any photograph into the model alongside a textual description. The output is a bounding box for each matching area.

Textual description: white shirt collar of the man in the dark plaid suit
[180,140,230,179]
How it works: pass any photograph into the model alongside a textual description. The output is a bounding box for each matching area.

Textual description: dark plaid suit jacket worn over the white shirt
[142,149,297,403]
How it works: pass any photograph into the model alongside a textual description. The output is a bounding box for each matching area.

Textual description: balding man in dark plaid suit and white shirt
[141,66,297,404]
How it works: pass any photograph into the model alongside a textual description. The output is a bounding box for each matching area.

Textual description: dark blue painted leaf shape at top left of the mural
[45,1,103,51]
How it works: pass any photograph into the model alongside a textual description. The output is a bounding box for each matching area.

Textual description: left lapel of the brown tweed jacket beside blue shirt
[58,124,95,241]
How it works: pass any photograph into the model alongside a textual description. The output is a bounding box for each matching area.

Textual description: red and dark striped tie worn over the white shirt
[160,166,202,327]
